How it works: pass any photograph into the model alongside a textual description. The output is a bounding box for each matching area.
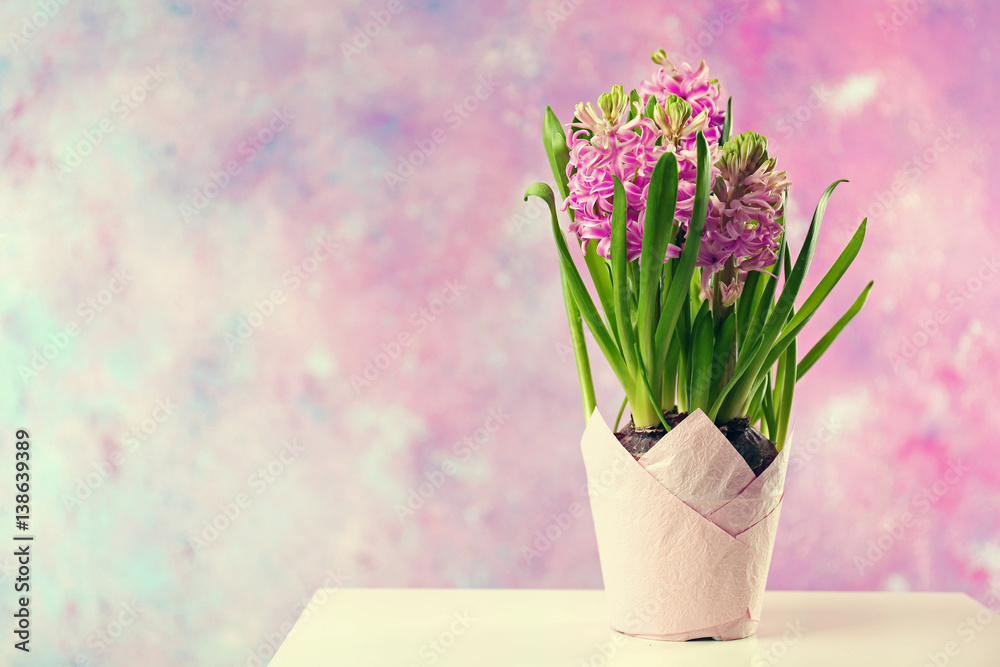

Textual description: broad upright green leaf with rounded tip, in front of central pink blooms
[640,152,677,396]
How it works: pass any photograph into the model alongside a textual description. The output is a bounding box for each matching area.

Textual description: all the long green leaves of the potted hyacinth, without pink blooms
[525,106,872,436]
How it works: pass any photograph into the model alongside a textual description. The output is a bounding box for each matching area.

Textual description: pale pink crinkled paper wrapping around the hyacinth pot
[582,410,788,641]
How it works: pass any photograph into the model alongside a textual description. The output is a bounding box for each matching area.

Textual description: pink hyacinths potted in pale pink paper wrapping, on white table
[525,51,872,640]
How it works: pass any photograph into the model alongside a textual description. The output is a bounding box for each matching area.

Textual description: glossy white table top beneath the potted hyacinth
[270,589,1000,667]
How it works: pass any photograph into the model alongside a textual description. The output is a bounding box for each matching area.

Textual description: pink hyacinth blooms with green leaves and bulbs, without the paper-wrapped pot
[525,51,872,450]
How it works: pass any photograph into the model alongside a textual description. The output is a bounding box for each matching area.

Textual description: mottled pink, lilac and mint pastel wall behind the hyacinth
[0,0,1000,666]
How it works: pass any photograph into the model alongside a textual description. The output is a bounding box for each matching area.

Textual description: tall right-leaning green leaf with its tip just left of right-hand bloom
[647,132,712,378]
